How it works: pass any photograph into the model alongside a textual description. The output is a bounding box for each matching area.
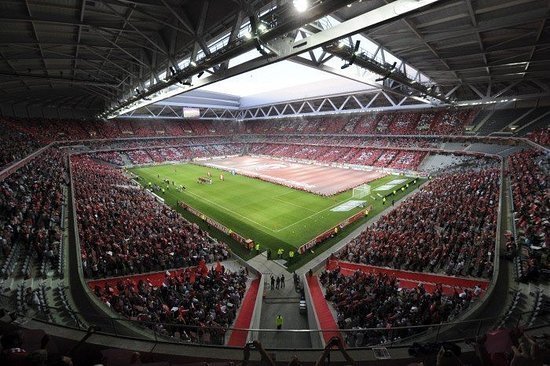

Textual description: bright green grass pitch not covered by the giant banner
[131,164,422,262]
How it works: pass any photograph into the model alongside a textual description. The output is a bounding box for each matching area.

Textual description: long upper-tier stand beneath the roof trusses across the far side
[3,110,488,144]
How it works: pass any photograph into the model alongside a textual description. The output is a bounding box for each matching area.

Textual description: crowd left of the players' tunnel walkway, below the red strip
[93,261,248,344]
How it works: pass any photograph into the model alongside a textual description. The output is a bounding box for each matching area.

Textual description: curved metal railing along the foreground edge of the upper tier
[0,294,550,349]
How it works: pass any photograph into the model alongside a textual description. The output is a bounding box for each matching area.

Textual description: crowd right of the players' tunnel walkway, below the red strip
[319,268,475,347]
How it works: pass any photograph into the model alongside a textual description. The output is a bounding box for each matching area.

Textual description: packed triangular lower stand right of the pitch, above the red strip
[339,168,499,278]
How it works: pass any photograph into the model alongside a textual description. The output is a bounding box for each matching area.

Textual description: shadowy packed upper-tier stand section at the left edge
[0,148,68,278]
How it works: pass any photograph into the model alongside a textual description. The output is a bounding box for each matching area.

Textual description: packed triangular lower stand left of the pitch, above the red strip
[71,157,229,277]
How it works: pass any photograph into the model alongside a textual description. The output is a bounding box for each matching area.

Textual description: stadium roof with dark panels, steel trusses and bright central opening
[0,0,550,116]
